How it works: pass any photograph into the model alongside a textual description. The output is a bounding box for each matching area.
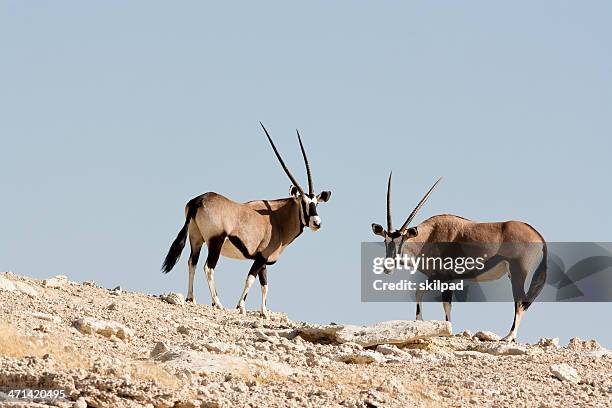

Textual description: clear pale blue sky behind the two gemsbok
[0,1,612,346]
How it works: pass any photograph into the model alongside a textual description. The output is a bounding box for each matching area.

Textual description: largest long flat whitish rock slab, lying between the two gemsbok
[336,320,452,347]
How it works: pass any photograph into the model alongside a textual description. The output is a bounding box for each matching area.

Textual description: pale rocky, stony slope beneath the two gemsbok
[0,273,612,407]
